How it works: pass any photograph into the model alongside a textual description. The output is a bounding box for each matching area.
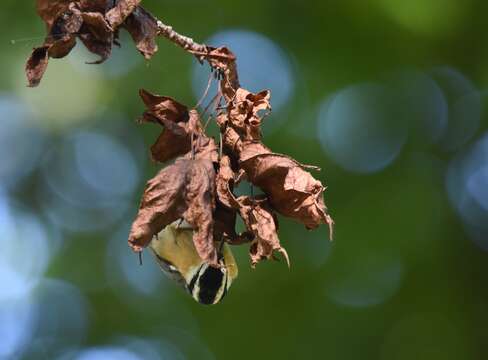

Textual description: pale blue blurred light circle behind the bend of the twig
[193,30,294,111]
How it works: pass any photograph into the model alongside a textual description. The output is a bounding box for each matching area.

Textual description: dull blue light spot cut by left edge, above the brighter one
[0,93,45,187]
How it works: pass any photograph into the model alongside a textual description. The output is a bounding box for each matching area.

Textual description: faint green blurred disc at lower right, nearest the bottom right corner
[326,253,405,308]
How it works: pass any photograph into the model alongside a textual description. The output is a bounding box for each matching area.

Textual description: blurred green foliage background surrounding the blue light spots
[0,0,488,360]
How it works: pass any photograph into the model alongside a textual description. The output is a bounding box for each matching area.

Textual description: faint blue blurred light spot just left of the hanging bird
[106,227,169,301]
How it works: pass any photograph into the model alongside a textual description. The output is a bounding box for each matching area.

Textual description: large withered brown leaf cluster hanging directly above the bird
[129,48,333,266]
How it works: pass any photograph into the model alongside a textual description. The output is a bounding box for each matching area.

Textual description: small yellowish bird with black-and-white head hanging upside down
[149,221,238,305]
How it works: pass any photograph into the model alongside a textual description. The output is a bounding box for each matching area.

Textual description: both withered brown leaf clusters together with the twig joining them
[26,0,333,266]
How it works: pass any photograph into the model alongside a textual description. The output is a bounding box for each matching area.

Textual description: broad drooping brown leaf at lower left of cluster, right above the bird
[129,159,218,266]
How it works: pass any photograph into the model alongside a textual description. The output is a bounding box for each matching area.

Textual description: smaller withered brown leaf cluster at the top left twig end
[26,0,158,86]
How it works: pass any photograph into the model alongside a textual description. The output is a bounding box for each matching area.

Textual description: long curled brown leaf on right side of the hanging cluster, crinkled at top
[218,84,333,238]
